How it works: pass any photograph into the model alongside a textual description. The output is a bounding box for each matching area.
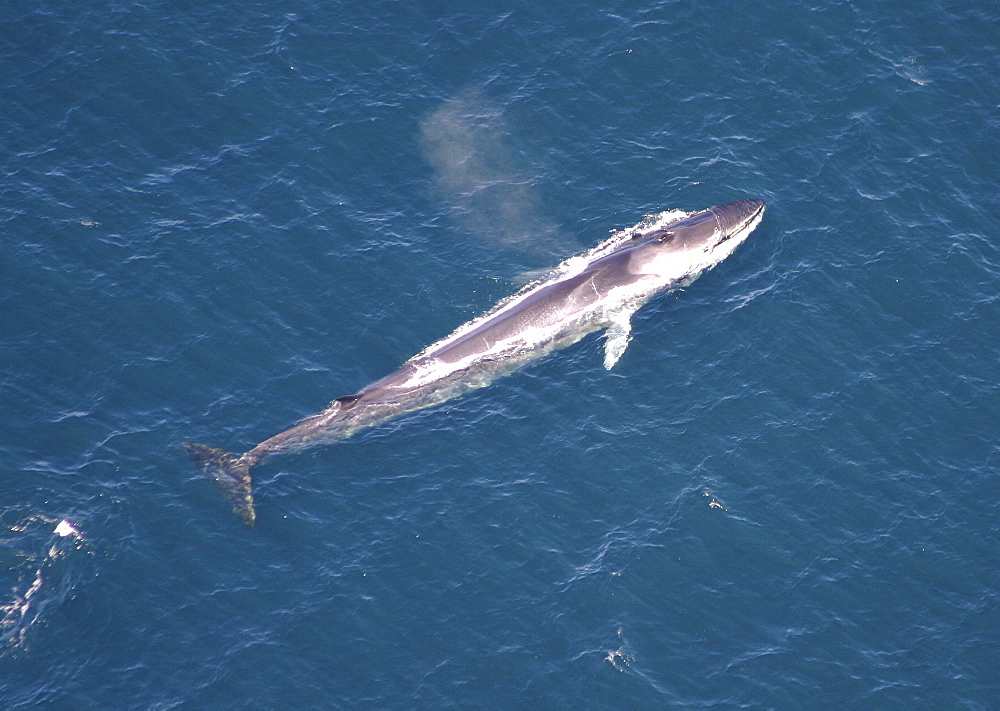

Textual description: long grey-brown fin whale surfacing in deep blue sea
[181,200,765,526]
